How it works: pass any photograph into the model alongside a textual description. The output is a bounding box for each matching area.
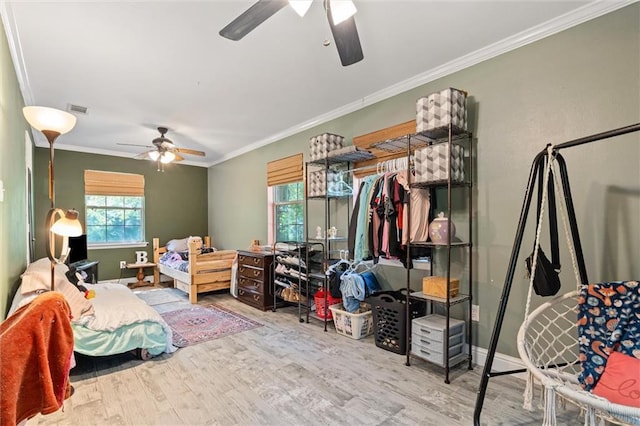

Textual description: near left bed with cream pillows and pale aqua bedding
[9,258,176,359]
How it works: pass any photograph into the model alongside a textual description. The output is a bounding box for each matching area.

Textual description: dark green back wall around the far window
[34,148,208,281]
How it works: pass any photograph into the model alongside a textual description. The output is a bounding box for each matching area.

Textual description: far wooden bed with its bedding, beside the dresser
[153,236,237,304]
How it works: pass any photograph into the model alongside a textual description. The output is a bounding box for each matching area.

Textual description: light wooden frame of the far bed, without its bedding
[153,236,237,304]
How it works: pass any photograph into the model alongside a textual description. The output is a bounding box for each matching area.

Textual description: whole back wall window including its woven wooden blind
[84,170,146,248]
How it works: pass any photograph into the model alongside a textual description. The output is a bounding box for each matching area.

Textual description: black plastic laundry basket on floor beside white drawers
[367,290,427,355]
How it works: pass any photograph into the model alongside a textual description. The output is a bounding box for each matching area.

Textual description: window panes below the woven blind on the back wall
[85,195,144,244]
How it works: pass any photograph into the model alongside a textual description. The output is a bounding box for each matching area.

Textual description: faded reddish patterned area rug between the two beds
[160,305,262,348]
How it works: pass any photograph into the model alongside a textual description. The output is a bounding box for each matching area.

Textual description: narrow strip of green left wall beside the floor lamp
[0,22,28,319]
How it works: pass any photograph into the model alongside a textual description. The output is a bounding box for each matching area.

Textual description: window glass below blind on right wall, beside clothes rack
[273,182,304,241]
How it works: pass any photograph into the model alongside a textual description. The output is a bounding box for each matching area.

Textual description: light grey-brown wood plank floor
[27,288,582,426]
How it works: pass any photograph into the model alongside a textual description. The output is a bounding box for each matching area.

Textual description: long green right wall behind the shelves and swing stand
[209,4,640,356]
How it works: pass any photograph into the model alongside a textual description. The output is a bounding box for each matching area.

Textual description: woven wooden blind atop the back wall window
[84,170,144,196]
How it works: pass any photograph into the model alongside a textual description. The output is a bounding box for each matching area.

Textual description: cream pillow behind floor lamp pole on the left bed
[20,258,94,320]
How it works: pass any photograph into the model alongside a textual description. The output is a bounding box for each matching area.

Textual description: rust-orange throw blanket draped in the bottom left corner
[0,291,73,426]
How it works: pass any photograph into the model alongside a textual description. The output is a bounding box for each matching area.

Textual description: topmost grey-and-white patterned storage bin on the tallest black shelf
[416,88,467,132]
